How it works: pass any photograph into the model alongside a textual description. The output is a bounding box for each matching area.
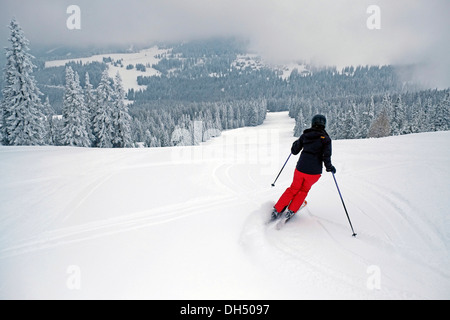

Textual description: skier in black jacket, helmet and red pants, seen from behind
[272,114,336,220]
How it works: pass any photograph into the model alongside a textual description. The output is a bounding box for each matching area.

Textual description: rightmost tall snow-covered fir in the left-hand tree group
[112,73,132,148]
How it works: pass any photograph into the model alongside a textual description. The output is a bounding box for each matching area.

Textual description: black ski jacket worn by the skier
[291,128,332,174]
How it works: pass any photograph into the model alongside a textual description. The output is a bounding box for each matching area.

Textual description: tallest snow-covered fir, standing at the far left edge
[1,19,46,145]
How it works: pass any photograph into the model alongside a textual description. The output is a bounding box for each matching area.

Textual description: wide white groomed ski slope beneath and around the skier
[0,112,450,300]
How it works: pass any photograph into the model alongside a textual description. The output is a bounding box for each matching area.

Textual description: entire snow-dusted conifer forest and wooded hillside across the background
[0,20,450,148]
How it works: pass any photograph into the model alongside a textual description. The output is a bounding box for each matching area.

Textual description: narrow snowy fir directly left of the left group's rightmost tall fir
[92,70,114,148]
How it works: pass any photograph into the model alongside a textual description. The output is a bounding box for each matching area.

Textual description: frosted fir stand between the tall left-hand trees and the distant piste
[130,99,267,147]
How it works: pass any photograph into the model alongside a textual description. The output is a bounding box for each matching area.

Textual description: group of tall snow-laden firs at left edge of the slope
[0,19,132,148]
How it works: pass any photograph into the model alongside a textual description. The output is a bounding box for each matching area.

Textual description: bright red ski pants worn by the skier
[275,170,321,212]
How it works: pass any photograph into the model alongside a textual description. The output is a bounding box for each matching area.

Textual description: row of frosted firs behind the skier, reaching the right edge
[289,89,450,139]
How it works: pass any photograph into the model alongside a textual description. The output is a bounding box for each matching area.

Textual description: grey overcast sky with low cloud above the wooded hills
[0,0,450,87]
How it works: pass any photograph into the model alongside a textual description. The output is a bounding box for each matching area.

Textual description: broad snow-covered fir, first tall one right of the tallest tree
[60,67,91,147]
